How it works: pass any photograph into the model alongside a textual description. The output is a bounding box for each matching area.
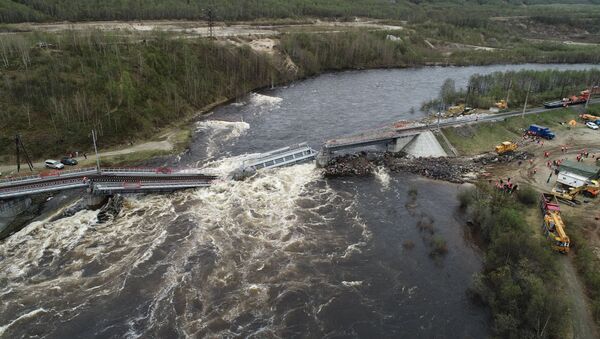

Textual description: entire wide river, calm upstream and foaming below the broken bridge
[0,65,588,338]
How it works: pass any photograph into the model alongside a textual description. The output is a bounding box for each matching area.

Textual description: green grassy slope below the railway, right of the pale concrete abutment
[444,105,588,155]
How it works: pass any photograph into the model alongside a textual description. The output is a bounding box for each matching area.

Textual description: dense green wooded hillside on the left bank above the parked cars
[0,32,288,157]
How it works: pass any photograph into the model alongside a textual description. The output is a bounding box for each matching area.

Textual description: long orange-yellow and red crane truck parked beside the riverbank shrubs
[540,194,571,254]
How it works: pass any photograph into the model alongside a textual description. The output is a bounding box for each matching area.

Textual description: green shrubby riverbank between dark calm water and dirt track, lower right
[459,186,571,338]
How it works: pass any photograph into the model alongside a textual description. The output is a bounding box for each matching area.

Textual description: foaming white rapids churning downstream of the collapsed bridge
[0,159,368,338]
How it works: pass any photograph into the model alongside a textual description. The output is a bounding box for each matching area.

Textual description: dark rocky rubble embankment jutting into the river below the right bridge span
[324,152,482,183]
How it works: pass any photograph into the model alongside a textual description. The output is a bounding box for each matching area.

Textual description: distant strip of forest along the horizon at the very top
[0,0,600,23]
